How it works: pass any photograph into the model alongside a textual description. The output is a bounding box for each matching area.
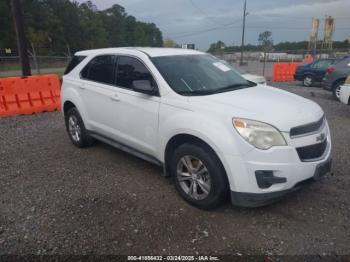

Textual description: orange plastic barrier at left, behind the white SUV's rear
[0,75,61,117]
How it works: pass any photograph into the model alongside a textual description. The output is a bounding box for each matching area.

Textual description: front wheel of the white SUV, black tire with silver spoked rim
[170,144,229,209]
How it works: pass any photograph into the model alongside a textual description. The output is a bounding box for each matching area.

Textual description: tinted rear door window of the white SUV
[81,55,116,85]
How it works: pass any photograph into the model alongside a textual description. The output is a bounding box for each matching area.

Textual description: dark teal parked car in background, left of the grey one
[294,58,337,86]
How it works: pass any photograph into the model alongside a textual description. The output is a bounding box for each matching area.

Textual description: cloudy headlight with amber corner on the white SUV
[232,118,287,150]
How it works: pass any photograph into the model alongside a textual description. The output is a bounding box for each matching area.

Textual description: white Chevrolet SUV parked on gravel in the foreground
[61,48,331,209]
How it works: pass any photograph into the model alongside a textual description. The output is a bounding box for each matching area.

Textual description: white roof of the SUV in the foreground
[76,47,203,57]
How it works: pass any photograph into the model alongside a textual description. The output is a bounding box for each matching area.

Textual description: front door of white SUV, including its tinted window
[112,56,160,156]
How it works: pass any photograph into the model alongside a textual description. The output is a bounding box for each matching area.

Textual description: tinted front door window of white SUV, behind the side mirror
[117,56,155,89]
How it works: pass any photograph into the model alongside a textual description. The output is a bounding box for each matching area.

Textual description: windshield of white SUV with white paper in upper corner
[152,55,255,96]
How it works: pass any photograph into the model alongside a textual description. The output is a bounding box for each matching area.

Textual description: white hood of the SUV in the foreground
[190,85,324,132]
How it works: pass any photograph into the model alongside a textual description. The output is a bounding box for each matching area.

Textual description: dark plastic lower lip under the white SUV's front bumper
[231,158,332,207]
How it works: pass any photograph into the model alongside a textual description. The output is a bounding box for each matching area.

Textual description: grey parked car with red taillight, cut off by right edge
[322,56,350,100]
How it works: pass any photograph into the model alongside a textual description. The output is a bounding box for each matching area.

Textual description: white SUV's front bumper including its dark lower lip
[221,121,331,206]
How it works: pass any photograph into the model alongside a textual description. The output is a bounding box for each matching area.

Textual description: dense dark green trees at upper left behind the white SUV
[0,0,163,55]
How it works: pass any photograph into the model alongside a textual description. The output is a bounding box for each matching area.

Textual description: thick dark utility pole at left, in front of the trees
[11,0,31,77]
